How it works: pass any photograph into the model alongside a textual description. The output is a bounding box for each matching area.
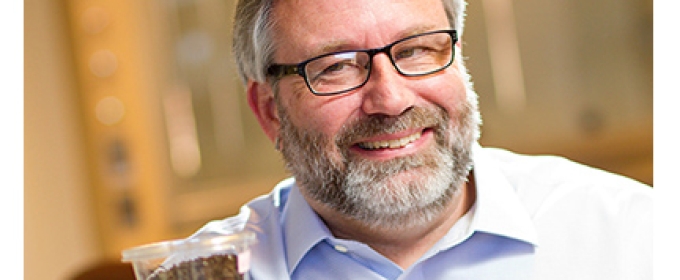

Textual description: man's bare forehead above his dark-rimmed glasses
[272,0,449,63]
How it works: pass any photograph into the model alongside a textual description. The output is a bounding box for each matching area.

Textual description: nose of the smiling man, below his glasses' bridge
[362,54,415,116]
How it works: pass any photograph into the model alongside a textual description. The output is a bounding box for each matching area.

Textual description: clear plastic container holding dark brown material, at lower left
[123,231,256,280]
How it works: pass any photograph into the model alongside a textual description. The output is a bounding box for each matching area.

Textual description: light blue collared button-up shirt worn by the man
[183,145,652,280]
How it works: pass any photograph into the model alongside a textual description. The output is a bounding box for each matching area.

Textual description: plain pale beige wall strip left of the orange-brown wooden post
[24,0,99,280]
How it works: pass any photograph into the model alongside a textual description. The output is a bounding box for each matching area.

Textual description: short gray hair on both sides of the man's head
[233,0,467,84]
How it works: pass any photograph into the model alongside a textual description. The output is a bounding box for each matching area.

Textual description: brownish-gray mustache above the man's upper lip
[335,107,449,148]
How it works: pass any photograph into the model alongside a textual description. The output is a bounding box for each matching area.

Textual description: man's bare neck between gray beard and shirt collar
[310,172,475,269]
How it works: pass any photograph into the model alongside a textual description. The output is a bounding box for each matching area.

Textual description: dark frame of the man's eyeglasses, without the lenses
[267,29,458,96]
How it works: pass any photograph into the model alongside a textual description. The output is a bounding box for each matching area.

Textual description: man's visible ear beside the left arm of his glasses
[246,80,280,142]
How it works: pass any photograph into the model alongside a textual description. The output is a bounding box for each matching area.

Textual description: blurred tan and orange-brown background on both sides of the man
[24,0,654,280]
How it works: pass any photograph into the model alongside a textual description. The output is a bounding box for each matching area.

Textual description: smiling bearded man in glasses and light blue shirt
[183,0,652,279]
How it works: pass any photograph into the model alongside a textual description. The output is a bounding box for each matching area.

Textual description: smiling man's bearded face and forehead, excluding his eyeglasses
[262,0,479,228]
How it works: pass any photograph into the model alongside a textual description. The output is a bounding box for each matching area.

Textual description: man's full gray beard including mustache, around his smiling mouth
[279,99,478,230]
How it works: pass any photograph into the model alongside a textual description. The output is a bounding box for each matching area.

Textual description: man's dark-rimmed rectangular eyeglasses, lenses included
[267,30,458,95]
